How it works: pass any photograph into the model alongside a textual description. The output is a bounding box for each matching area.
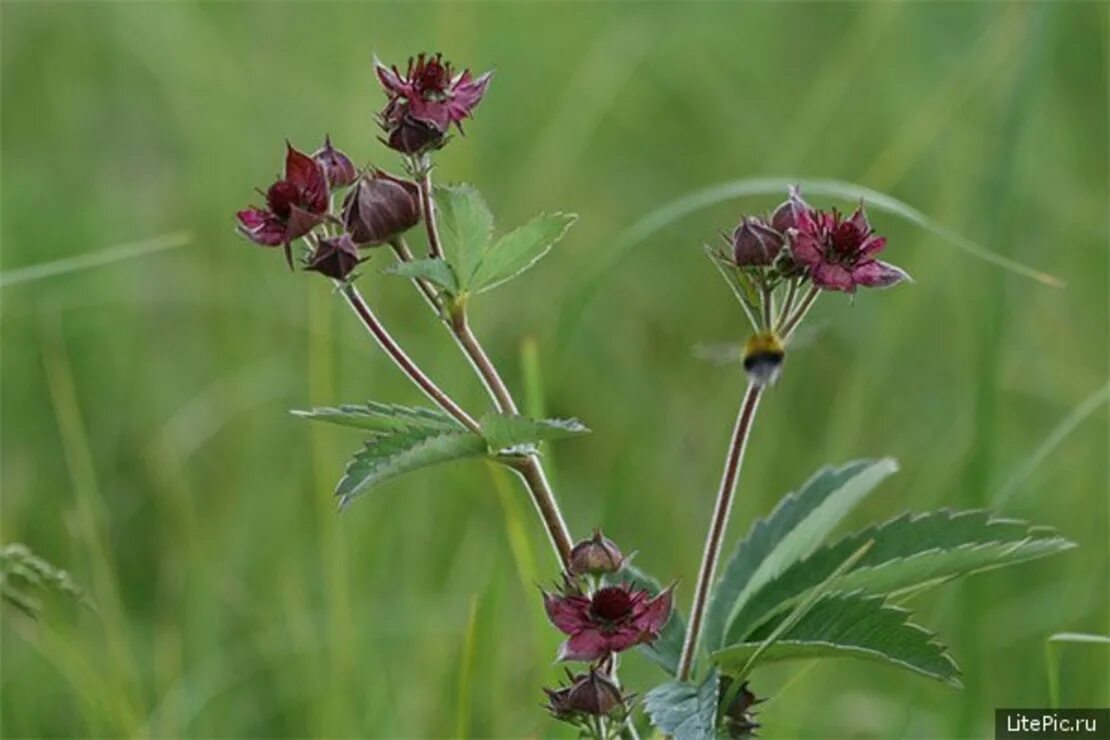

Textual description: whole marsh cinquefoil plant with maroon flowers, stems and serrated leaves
[231,54,1072,739]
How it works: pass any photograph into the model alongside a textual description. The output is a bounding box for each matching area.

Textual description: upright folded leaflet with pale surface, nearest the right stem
[704,458,898,650]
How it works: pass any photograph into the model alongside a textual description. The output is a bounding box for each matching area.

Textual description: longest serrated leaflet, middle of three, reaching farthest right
[726,509,1074,642]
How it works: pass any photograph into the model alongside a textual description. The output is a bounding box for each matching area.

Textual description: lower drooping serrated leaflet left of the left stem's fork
[335,428,486,508]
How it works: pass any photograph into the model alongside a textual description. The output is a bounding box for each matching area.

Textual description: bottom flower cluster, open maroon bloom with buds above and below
[543,530,673,723]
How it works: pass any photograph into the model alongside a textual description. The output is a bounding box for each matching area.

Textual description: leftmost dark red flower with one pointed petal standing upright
[235,143,327,267]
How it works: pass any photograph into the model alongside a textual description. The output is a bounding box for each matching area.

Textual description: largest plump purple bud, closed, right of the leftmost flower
[343,170,421,246]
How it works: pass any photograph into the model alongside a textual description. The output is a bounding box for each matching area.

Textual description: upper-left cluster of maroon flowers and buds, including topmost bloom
[235,54,491,282]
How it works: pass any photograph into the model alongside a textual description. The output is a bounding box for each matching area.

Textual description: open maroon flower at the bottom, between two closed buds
[544,584,672,660]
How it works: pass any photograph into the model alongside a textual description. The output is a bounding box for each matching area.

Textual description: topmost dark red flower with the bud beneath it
[374,54,493,154]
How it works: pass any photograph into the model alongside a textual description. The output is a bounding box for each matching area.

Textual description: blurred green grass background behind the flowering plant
[0,2,1110,738]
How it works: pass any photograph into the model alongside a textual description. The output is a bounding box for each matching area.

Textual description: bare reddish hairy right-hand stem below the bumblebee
[678,383,763,681]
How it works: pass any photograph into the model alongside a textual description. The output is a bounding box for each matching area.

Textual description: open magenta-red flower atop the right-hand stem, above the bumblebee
[790,199,909,293]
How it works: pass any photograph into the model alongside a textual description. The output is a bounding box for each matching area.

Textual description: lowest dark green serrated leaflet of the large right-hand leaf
[713,594,960,687]
